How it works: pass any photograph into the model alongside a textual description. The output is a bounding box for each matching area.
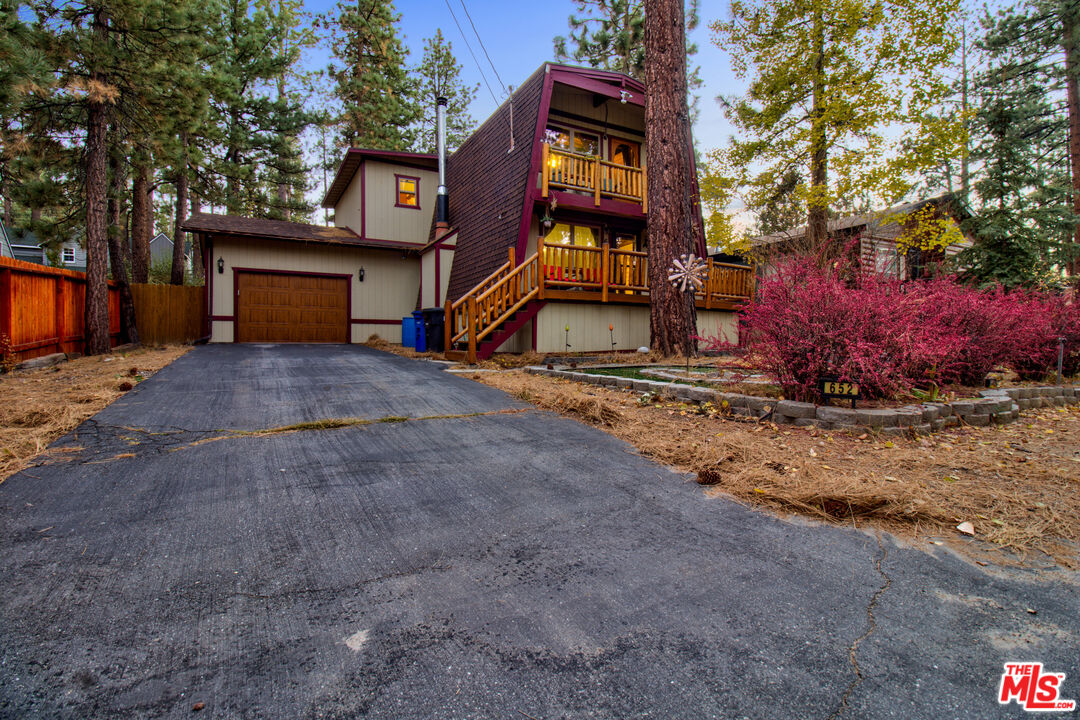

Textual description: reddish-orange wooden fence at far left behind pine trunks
[0,257,120,361]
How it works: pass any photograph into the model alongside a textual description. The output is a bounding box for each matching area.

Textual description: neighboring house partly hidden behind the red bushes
[751,194,972,280]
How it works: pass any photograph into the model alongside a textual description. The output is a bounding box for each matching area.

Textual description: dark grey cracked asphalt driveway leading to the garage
[0,345,1080,720]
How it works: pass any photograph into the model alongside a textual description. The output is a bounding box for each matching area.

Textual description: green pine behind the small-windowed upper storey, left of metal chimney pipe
[321,0,417,150]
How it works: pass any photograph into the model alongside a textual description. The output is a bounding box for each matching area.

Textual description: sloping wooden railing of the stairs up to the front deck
[445,247,542,363]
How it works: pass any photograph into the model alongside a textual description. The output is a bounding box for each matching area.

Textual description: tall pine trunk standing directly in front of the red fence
[83,10,109,355]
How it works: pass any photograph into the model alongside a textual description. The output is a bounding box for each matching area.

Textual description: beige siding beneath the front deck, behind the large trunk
[529,302,739,353]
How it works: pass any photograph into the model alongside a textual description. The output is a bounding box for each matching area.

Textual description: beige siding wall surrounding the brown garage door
[211,239,420,342]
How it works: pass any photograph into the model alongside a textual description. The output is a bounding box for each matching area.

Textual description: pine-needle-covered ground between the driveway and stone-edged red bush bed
[474,371,1080,567]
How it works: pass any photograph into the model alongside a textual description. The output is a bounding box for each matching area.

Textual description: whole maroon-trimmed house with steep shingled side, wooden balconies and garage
[184,64,753,357]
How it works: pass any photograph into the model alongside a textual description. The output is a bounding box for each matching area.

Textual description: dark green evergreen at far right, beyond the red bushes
[959,6,1077,286]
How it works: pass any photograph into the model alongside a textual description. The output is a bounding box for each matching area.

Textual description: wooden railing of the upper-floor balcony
[541,142,649,213]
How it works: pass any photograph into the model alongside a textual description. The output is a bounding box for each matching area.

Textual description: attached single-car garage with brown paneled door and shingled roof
[184,214,423,343]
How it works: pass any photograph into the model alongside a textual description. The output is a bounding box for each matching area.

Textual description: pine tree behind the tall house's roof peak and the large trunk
[553,0,702,122]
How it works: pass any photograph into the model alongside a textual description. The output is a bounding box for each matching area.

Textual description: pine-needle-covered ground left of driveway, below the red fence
[0,345,190,483]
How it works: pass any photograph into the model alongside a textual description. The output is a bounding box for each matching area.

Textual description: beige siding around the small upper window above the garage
[353,161,438,244]
